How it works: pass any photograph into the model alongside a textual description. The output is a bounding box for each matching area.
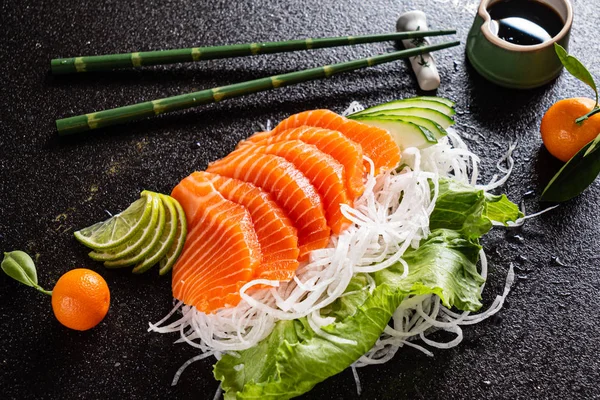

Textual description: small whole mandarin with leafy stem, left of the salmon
[52,268,110,331]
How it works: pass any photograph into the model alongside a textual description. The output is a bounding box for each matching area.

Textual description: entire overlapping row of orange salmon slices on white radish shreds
[166,110,400,313]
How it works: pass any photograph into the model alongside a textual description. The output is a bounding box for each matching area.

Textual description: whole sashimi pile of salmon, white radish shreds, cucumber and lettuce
[150,97,523,399]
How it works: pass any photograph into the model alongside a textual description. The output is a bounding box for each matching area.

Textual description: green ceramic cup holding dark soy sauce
[466,0,573,89]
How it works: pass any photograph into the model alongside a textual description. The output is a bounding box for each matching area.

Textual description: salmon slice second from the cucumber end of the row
[238,126,365,200]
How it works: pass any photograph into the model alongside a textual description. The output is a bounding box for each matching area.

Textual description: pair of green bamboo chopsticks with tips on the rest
[51,30,460,136]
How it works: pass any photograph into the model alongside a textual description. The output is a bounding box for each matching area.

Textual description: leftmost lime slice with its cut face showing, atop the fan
[75,196,152,250]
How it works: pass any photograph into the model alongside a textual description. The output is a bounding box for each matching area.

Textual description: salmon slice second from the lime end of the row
[185,171,299,281]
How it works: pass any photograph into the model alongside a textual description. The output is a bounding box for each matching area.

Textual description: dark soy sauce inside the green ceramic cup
[488,0,565,46]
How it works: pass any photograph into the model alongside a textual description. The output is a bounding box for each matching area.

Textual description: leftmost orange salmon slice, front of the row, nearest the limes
[171,179,262,313]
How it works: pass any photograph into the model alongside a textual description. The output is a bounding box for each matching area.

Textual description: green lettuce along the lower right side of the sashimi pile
[214,179,519,400]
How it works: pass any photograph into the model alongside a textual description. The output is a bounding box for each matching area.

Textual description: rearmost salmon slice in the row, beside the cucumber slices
[262,110,400,174]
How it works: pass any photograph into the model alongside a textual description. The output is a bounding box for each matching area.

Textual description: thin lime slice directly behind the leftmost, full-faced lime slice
[88,191,162,261]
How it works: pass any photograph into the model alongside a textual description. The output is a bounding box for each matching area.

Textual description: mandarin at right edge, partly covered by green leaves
[540,97,600,162]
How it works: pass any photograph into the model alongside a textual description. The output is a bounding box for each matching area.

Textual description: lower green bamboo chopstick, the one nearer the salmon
[56,42,460,136]
